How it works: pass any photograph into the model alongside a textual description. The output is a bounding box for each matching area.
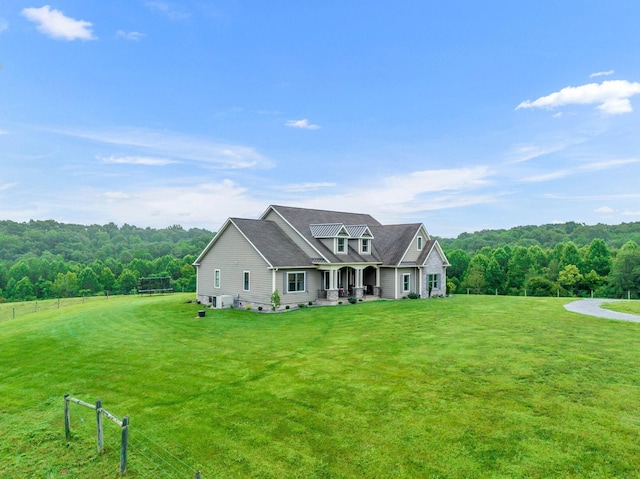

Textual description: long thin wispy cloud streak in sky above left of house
[53,128,273,169]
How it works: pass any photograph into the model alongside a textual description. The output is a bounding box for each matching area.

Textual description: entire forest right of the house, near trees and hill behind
[440,222,640,299]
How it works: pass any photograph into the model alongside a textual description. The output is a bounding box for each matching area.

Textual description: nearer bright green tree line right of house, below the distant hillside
[445,238,640,299]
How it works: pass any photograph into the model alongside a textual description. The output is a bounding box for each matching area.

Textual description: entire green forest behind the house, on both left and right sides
[0,220,640,302]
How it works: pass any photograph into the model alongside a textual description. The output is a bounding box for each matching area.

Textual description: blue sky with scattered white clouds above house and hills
[0,0,640,237]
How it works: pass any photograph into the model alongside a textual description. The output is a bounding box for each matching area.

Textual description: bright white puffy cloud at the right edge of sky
[516,80,640,115]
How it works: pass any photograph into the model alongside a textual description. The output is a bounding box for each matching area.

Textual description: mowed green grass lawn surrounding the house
[0,294,640,478]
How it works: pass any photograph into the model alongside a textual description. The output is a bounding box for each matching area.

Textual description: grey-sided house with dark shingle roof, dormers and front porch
[194,205,449,308]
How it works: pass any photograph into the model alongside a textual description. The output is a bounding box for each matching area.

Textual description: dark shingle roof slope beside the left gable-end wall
[231,218,313,267]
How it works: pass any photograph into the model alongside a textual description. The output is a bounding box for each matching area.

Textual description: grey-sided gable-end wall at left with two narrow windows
[197,224,272,304]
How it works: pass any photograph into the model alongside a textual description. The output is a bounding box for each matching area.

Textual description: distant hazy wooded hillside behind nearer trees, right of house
[438,221,640,252]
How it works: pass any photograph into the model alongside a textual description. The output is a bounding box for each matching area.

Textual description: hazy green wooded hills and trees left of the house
[0,220,214,301]
